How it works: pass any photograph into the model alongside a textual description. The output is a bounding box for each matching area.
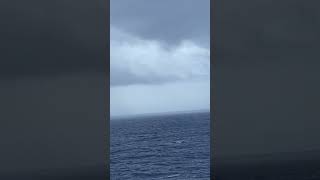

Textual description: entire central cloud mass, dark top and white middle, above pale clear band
[111,0,210,85]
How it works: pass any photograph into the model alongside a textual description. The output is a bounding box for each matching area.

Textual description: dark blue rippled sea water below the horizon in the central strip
[110,113,210,180]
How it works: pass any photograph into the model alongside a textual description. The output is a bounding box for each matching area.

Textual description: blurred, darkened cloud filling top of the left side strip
[0,0,108,78]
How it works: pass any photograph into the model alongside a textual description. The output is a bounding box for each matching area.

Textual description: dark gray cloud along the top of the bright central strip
[111,0,210,46]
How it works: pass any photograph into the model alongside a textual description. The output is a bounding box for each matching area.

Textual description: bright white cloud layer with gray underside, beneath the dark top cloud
[110,27,210,86]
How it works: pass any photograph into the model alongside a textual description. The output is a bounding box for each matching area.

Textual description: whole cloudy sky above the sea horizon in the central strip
[110,0,210,116]
